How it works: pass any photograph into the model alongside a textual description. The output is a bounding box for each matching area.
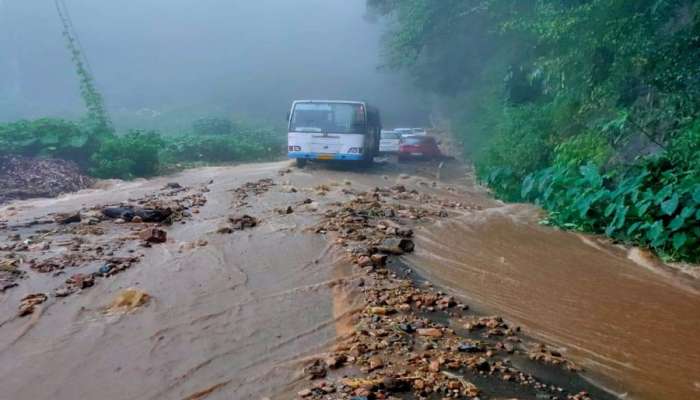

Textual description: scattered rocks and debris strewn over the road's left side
[0,183,208,317]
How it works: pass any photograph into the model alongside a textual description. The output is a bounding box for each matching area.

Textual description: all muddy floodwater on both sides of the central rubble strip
[0,162,700,400]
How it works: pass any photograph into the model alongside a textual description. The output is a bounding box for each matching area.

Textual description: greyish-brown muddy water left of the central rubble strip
[0,163,370,400]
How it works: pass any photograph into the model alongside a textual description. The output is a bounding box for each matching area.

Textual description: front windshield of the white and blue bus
[289,103,367,133]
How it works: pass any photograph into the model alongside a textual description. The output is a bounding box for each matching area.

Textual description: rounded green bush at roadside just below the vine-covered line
[90,131,163,179]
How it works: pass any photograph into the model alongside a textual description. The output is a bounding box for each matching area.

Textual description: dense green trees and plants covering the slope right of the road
[374,0,700,261]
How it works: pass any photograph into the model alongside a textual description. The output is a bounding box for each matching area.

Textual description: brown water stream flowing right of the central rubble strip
[410,200,700,400]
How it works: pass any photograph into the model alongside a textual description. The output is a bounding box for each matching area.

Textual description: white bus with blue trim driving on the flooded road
[288,100,382,167]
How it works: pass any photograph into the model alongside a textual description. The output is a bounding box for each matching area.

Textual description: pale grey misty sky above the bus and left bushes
[0,0,425,130]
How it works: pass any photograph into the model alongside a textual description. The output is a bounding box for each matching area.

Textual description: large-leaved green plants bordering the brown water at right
[521,157,700,261]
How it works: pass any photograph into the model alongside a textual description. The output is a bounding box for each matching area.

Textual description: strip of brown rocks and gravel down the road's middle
[297,185,590,400]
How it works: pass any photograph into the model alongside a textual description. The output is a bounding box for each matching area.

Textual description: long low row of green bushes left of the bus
[0,118,286,179]
